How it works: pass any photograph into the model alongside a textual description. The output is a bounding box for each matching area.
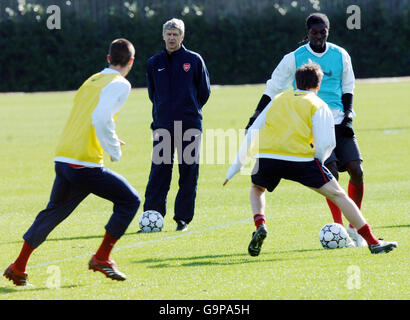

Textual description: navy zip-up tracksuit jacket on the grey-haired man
[147,46,210,130]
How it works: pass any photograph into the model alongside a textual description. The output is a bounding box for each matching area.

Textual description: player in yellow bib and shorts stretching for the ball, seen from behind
[223,62,397,256]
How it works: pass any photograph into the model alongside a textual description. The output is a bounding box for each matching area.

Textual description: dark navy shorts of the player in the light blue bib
[325,125,363,172]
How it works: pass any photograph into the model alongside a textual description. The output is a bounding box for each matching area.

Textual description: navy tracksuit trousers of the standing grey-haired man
[144,129,201,223]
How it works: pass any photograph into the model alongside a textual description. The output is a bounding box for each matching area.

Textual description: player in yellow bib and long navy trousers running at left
[4,39,141,286]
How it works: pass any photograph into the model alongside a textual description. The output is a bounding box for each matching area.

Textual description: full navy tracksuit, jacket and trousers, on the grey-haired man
[144,46,210,223]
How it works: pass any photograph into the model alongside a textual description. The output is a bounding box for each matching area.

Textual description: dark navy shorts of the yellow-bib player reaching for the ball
[251,158,333,192]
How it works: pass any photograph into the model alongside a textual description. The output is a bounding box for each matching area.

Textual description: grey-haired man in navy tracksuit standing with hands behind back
[144,19,210,231]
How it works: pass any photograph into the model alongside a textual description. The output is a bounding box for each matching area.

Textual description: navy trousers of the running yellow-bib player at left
[23,162,141,248]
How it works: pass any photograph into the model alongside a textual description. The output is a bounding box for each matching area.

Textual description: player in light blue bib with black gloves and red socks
[246,13,367,246]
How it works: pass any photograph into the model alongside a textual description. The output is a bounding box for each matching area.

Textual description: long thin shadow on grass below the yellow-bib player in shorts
[133,248,336,269]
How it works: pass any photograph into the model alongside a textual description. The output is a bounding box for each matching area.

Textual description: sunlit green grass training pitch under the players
[0,81,410,300]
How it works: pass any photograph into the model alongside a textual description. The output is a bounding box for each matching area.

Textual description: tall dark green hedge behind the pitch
[0,1,410,92]
